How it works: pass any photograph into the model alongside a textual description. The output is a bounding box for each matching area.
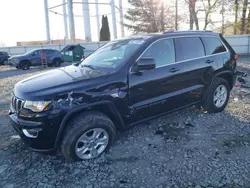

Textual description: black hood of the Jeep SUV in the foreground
[14,65,107,100]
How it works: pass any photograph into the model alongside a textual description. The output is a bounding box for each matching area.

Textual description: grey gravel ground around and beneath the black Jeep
[0,63,250,188]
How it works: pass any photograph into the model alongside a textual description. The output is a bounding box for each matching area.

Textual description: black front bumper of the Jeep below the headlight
[9,110,62,153]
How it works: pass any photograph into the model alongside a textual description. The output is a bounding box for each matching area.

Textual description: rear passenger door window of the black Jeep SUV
[175,37,205,61]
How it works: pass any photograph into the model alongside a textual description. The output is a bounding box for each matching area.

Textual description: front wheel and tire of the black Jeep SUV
[60,112,116,161]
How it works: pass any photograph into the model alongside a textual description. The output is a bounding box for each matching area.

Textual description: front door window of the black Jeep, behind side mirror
[142,39,175,67]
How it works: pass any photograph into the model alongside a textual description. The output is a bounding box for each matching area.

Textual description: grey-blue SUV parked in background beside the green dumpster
[9,49,63,70]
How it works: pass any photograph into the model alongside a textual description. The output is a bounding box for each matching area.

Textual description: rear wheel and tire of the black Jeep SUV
[203,77,230,113]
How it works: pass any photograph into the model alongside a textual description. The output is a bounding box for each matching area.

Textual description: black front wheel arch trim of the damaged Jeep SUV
[54,101,126,148]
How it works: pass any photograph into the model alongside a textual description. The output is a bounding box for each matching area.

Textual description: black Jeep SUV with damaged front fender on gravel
[9,31,237,160]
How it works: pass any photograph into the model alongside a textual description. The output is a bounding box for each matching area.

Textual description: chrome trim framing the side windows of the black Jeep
[129,35,229,74]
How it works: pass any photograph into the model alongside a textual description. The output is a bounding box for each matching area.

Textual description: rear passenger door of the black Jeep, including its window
[174,36,217,107]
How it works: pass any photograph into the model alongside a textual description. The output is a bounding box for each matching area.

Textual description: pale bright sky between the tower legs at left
[0,0,128,46]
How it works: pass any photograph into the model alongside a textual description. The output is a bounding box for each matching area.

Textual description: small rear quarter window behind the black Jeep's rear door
[203,37,227,55]
